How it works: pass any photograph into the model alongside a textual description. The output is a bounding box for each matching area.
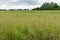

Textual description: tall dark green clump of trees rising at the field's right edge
[32,2,60,10]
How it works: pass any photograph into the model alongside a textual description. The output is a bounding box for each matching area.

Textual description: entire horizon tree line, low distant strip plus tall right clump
[0,2,60,11]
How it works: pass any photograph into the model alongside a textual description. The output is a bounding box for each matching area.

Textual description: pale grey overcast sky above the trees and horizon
[0,0,60,9]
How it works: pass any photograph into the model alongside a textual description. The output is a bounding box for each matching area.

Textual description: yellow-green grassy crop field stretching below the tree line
[0,10,60,40]
